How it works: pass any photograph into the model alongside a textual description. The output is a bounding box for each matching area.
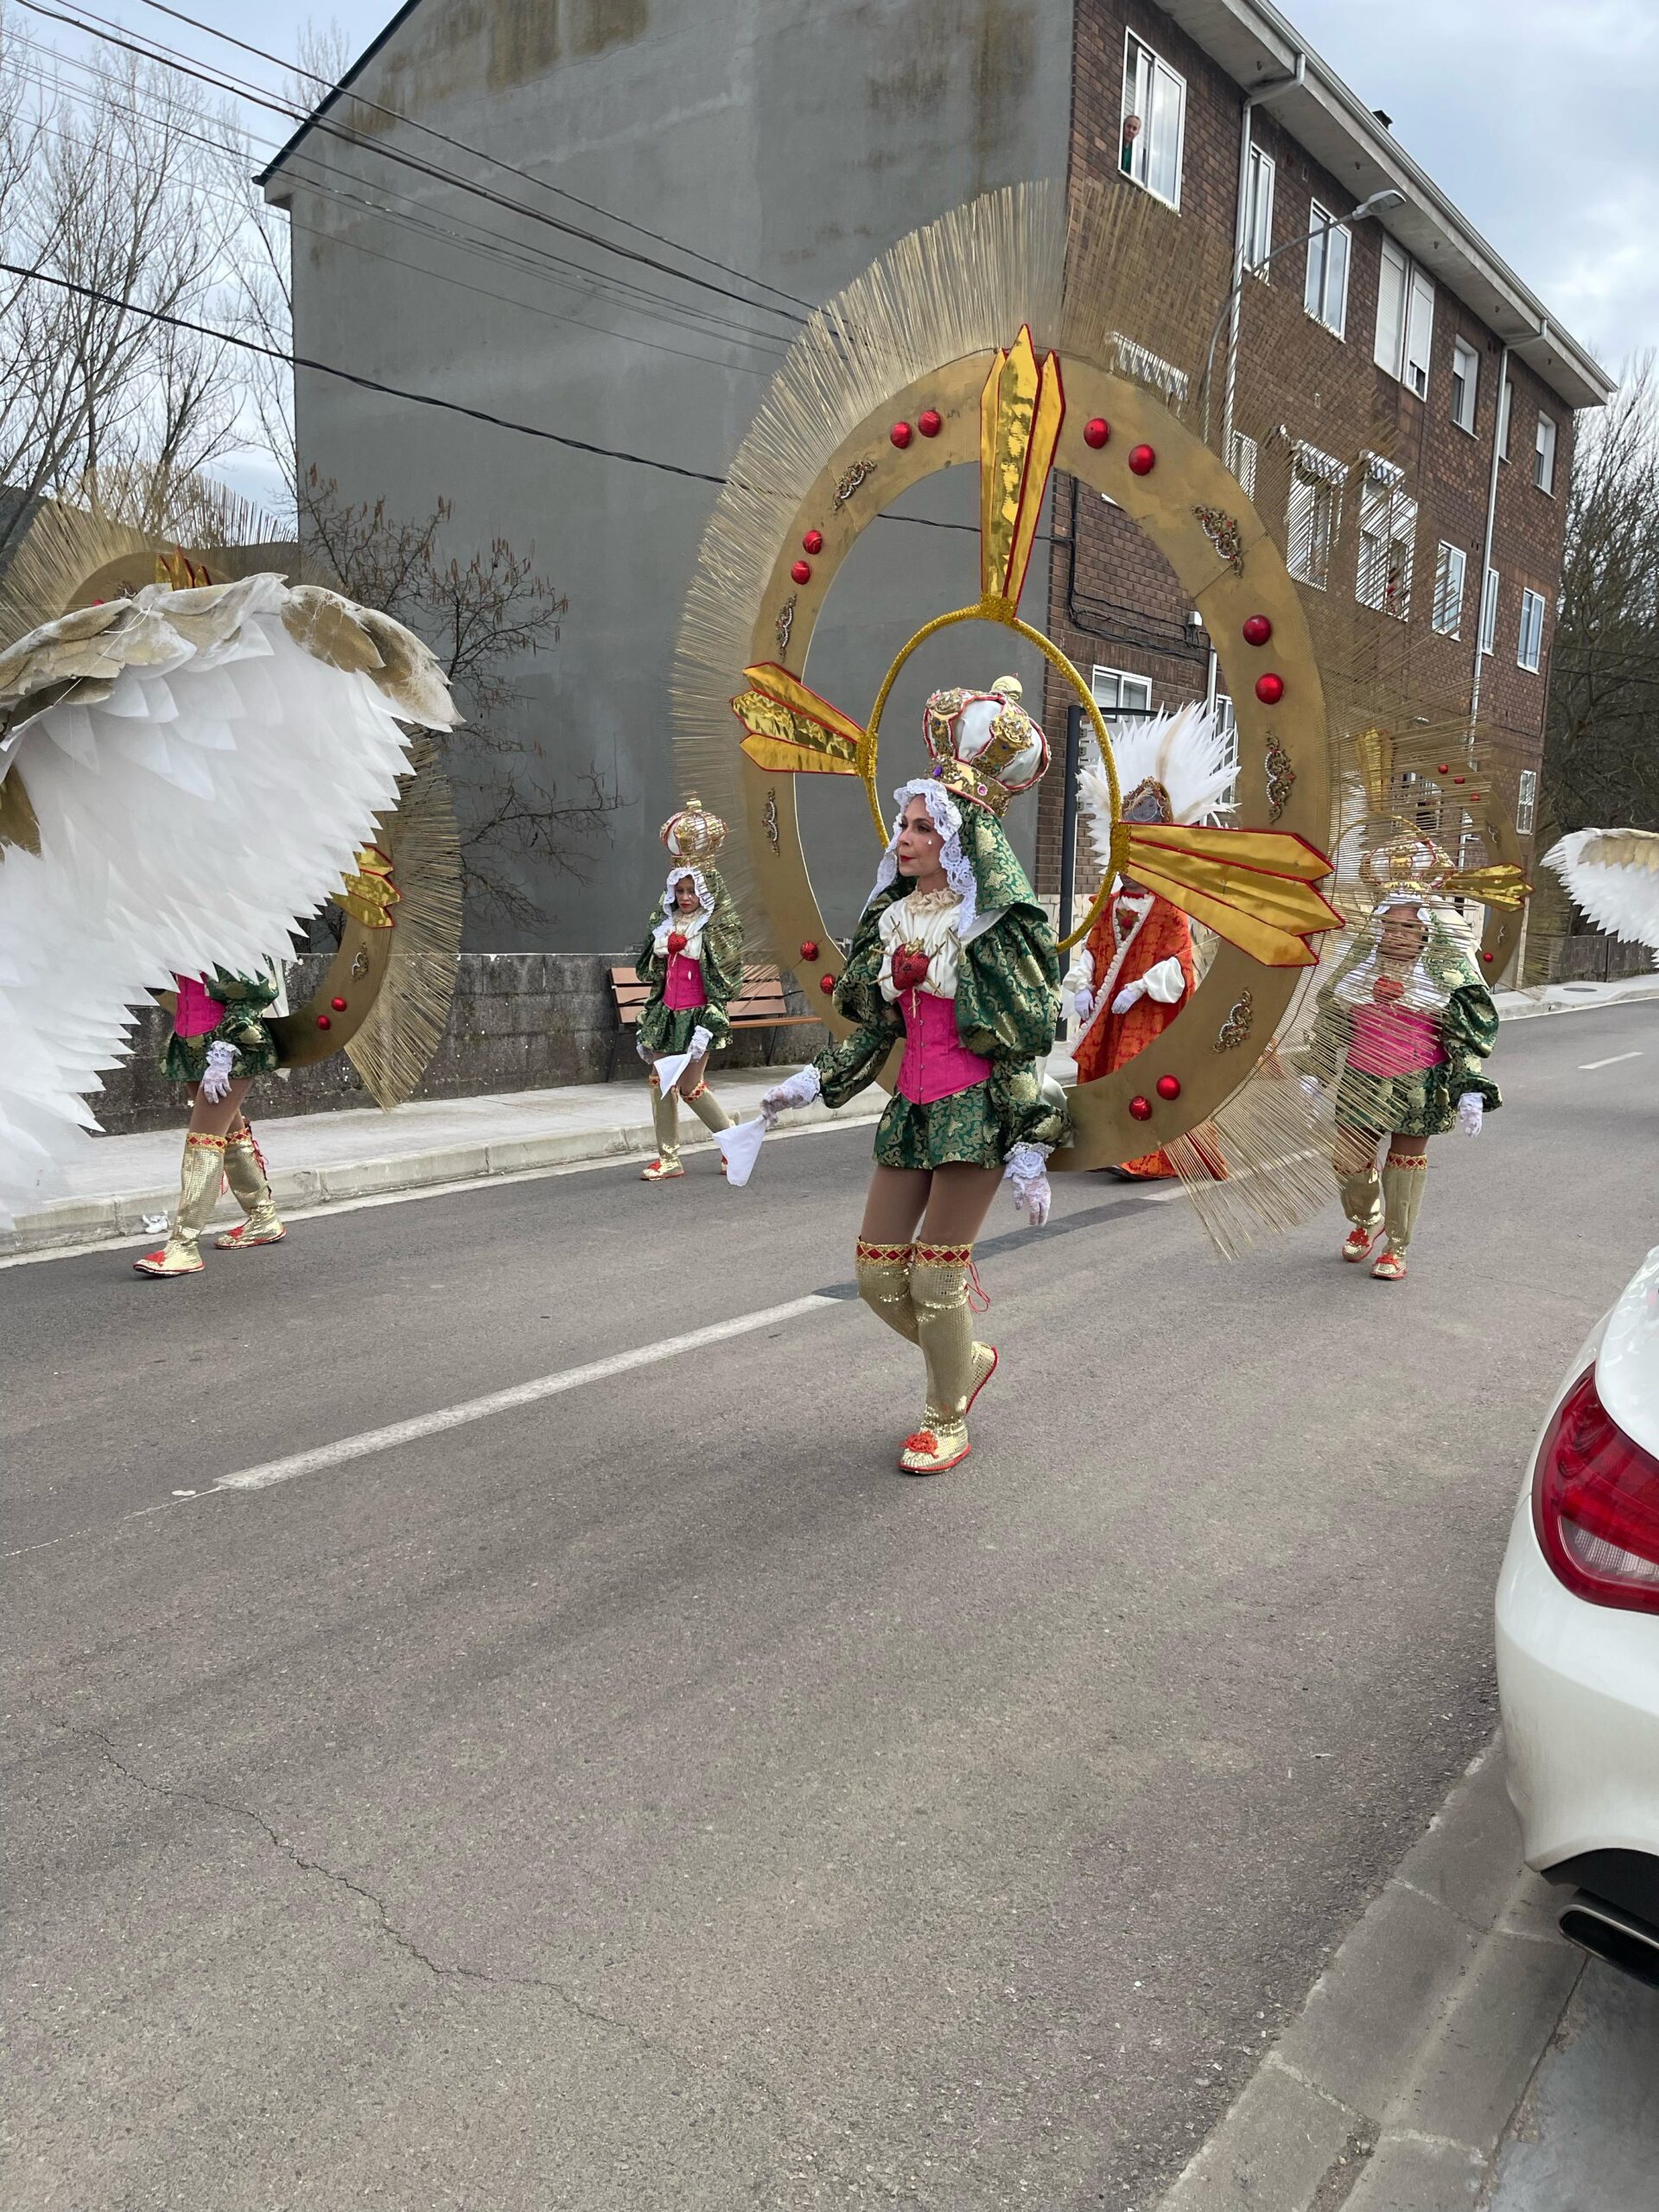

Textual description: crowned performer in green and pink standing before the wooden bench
[635,798,743,1184]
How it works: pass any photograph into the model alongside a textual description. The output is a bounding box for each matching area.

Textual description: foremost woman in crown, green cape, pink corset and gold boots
[761,677,1071,1476]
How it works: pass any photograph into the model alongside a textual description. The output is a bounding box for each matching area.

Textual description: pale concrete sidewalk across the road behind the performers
[0,976,1659,1259]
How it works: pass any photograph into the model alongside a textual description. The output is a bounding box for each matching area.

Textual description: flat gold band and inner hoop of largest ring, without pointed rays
[732,332,1330,1168]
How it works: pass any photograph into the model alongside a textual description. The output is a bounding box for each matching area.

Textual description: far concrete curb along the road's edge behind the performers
[0,1102,880,1259]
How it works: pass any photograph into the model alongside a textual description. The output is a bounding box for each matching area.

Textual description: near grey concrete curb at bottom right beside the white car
[1157,1743,1584,2212]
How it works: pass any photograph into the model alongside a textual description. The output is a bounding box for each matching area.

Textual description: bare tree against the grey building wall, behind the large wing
[299,469,620,925]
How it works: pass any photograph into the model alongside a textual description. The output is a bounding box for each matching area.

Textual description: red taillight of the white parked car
[1533,1367,1659,1612]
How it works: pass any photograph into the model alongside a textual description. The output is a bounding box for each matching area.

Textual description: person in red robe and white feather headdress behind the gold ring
[1068,706,1236,1181]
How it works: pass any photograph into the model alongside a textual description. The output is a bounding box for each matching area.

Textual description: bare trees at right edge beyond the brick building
[1540,354,1659,836]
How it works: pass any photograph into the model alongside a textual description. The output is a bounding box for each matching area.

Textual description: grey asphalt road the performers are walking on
[0,1004,1659,2212]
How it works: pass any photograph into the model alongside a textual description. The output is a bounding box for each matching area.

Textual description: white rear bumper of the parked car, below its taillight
[1497,1497,1659,1875]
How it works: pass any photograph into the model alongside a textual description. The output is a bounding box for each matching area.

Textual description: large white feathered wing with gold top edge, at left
[0,575,458,1221]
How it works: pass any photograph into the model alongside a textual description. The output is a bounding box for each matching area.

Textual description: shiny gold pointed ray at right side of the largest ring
[1113,823,1344,967]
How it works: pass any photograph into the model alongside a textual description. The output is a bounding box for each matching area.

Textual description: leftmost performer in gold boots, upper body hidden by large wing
[133,969,288,1276]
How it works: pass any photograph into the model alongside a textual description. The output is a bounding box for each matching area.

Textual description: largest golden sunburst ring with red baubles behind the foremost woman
[677,188,1343,1168]
